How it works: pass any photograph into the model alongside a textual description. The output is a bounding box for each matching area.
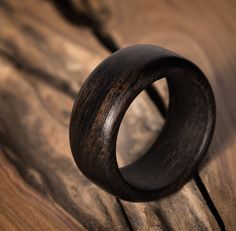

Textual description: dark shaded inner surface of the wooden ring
[120,75,209,191]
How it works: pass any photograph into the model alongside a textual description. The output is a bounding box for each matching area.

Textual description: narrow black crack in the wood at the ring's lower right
[194,173,226,231]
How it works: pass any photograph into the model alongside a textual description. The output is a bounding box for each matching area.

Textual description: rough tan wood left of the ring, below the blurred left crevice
[0,56,131,230]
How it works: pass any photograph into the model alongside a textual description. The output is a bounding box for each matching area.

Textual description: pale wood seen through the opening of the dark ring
[116,78,169,173]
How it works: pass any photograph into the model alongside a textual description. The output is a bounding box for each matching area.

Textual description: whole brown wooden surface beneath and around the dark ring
[0,0,236,230]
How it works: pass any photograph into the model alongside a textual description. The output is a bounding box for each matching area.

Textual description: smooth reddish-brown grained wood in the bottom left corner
[0,150,84,231]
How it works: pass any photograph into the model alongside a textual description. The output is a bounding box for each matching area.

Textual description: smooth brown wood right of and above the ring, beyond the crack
[94,0,236,230]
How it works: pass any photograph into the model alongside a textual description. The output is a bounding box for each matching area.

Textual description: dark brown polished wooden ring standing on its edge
[70,45,216,201]
